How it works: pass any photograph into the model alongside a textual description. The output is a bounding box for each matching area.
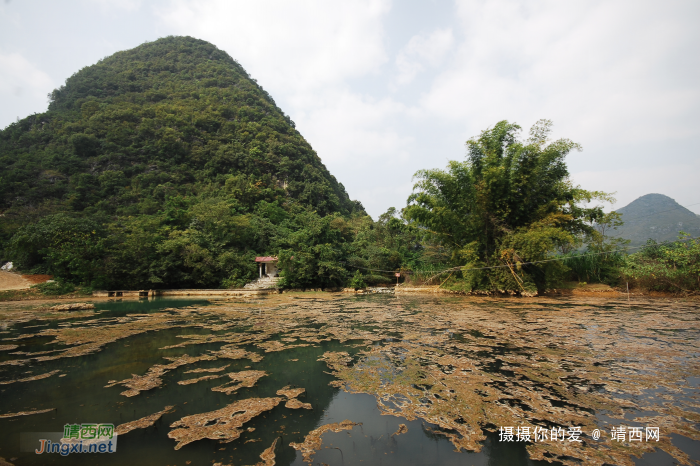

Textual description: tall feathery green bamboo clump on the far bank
[404,120,610,292]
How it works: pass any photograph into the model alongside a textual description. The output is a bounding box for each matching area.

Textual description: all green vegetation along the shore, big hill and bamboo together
[0,37,700,294]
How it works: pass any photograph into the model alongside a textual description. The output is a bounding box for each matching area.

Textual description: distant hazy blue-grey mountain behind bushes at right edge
[613,194,700,246]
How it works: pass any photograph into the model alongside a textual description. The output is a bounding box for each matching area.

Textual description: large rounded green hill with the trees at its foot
[0,37,372,288]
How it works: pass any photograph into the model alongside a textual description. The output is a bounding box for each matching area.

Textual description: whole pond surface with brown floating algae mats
[0,294,700,465]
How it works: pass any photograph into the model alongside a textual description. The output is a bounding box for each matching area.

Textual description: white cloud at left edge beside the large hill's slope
[0,50,54,127]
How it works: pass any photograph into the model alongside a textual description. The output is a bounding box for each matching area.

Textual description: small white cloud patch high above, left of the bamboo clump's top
[396,28,454,84]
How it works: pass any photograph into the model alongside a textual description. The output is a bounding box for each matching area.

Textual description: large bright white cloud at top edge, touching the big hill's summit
[156,0,389,95]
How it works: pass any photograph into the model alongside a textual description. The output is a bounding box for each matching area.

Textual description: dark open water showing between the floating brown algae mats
[0,297,699,466]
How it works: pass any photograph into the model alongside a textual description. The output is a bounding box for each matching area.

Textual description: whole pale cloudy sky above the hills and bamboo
[0,0,700,218]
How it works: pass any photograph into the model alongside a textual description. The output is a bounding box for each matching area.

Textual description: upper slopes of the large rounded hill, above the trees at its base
[0,37,358,215]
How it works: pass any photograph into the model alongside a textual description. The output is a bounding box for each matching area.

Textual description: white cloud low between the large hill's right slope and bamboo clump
[295,90,415,217]
